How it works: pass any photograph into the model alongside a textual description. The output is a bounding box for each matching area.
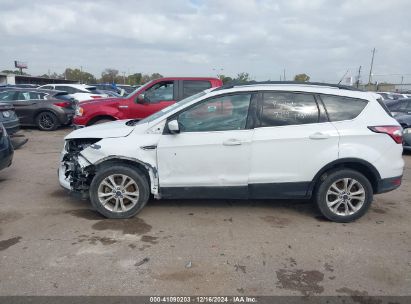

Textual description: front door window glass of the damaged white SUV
[177,94,252,132]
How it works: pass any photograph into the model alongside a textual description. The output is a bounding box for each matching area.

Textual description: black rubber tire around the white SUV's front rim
[89,164,150,219]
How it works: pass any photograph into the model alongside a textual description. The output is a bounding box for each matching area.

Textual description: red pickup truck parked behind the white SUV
[73,77,223,127]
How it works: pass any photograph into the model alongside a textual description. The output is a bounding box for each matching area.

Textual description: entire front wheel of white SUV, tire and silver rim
[90,165,150,218]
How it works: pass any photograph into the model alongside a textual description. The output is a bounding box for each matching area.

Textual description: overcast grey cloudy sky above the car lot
[0,0,411,82]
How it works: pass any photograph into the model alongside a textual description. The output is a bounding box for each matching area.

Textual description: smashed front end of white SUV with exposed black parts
[59,138,101,198]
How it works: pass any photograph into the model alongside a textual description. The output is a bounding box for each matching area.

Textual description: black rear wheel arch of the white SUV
[309,158,381,193]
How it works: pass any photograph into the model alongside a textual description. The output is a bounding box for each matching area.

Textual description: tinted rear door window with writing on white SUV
[259,92,319,127]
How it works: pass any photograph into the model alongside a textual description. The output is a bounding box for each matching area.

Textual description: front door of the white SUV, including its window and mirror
[157,92,256,198]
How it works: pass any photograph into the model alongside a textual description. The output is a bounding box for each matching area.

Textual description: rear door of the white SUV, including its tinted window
[249,91,339,198]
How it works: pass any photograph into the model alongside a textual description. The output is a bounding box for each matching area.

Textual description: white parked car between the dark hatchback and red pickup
[38,83,108,101]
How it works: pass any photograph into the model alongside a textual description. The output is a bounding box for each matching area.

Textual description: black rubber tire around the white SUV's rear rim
[314,169,373,223]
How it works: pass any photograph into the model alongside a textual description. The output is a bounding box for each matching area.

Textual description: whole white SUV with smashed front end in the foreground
[59,82,404,222]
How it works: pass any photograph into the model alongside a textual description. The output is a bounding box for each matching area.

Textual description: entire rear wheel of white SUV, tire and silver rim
[315,169,373,223]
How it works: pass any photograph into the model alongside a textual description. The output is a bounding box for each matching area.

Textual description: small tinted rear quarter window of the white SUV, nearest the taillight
[321,95,367,121]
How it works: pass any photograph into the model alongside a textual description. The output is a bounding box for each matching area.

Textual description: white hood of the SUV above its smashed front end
[65,119,137,139]
